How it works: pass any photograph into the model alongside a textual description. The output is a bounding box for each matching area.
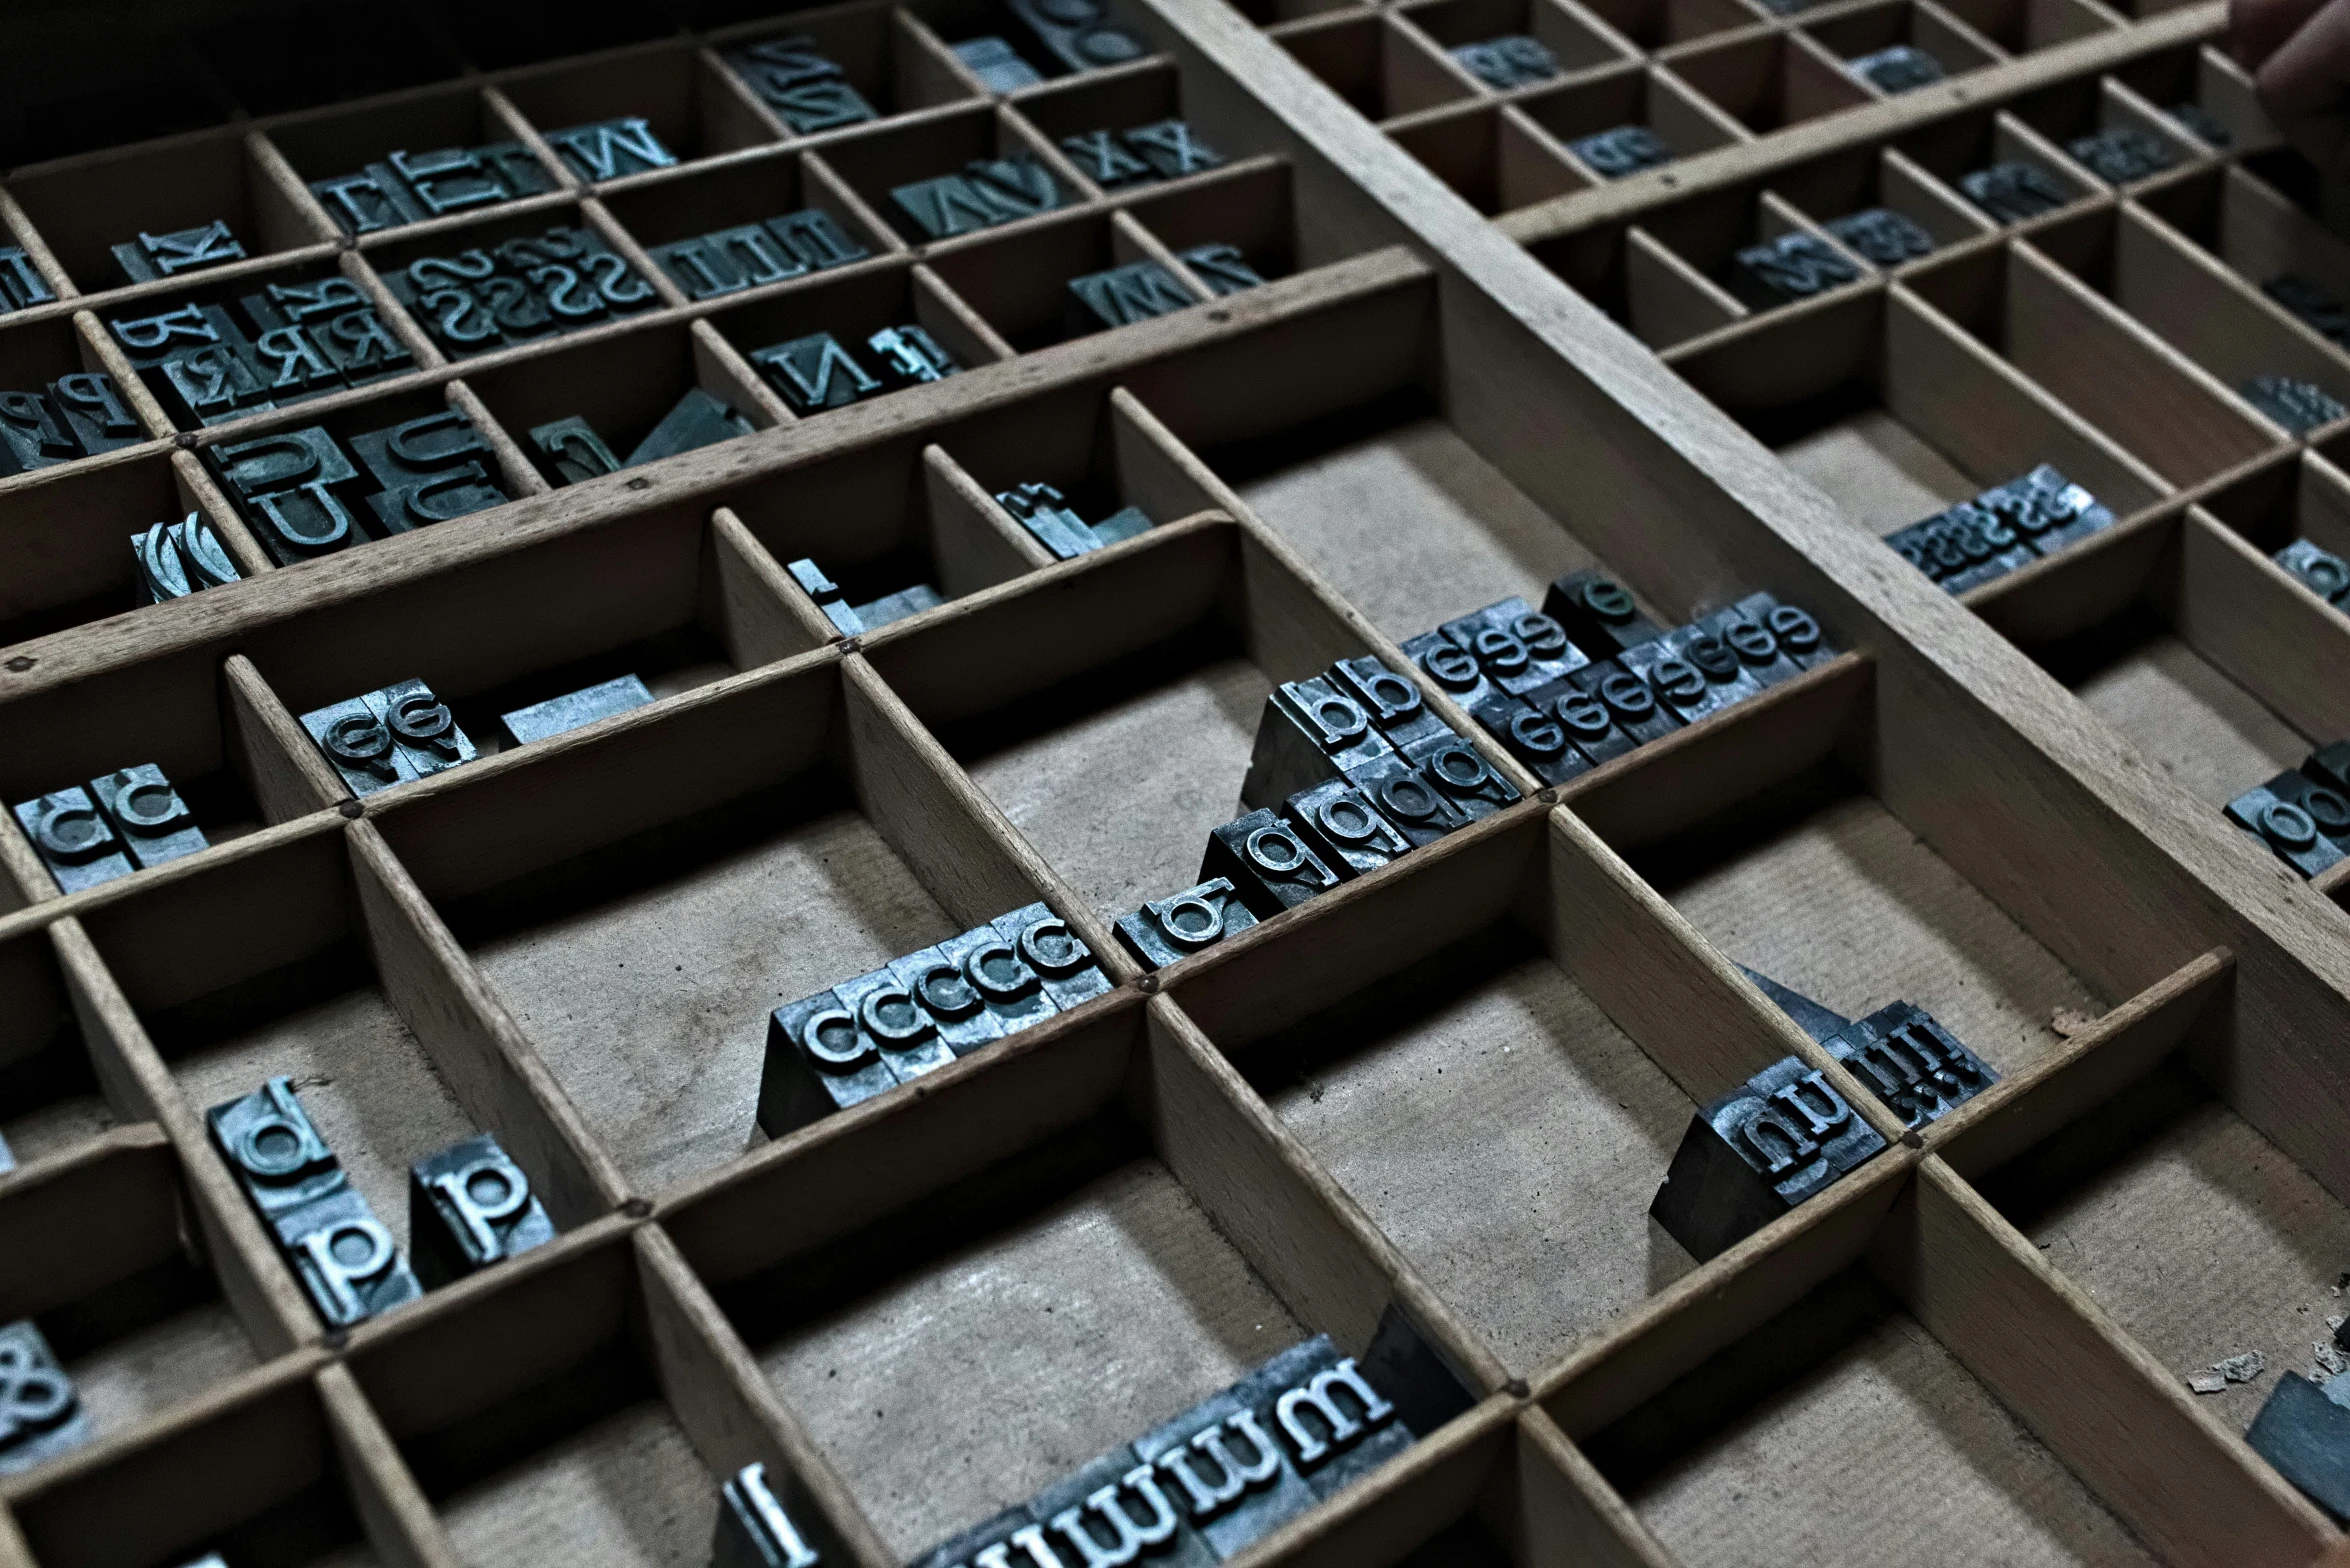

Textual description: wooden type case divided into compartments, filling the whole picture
[0,0,2350,1568]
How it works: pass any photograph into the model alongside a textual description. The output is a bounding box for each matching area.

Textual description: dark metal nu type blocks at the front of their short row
[1647,1056,1885,1262]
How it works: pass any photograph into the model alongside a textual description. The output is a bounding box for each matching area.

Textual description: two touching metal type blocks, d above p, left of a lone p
[204,1077,423,1328]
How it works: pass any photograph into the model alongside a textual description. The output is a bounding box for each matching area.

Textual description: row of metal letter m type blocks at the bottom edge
[914,1319,1438,1568]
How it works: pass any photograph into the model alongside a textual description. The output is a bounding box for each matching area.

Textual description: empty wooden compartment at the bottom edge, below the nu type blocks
[1584,1269,2155,1568]
